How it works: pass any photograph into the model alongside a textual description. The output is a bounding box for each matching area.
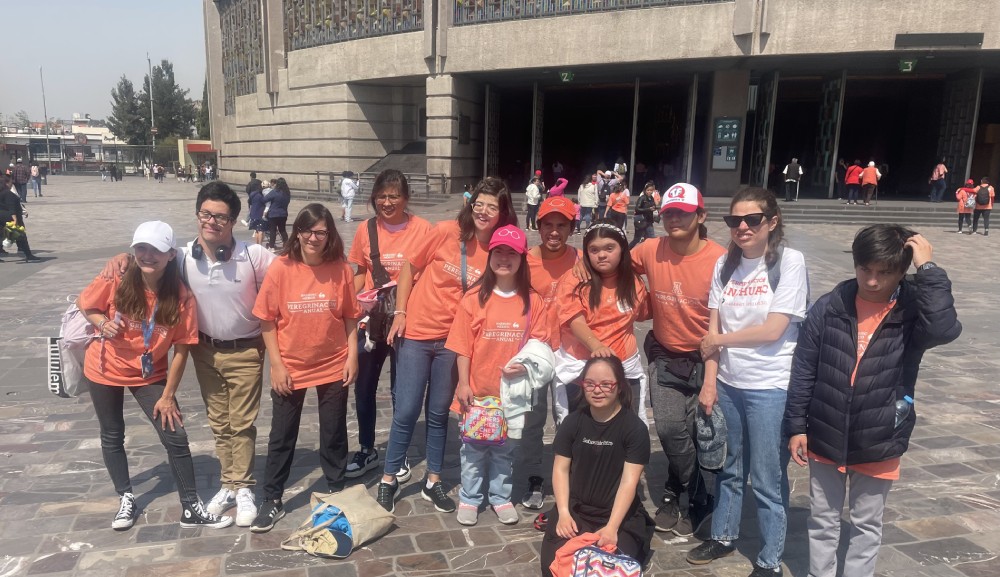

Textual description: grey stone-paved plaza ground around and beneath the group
[0,176,1000,577]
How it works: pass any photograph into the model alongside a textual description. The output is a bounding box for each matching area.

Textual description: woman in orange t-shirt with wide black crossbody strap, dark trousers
[346,168,431,479]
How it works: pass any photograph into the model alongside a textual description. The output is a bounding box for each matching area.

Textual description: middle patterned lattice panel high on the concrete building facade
[285,0,424,50]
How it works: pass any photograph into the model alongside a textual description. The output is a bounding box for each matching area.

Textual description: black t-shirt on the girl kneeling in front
[553,407,649,515]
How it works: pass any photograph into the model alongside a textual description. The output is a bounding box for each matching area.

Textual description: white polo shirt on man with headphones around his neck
[178,241,276,341]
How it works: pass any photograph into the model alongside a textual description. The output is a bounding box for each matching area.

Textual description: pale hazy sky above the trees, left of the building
[0,0,205,122]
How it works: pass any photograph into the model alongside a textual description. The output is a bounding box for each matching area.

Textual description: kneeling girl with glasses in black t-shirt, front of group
[540,356,654,577]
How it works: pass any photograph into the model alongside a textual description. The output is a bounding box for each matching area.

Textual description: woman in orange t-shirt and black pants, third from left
[250,202,360,533]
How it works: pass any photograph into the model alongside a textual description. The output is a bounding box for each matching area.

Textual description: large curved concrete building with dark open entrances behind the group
[204,0,1000,196]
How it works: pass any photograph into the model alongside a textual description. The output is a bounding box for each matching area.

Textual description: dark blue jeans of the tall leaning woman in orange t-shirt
[384,339,458,475]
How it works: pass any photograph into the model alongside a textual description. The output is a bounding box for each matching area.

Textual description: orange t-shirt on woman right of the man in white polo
[253,256,361,389]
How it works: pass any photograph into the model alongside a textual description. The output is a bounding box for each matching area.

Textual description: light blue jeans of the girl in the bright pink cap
[458,438,517,507]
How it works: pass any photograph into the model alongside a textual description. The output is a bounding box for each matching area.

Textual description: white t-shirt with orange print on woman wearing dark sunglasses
[708,248,809,390]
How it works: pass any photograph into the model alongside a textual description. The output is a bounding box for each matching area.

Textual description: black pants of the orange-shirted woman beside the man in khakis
[264,381,347,501]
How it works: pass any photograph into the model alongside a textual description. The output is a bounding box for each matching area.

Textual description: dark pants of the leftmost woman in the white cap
[87,379,198,504]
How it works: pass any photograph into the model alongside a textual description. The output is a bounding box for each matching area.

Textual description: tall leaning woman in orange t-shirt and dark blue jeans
[377,177,517,513]
